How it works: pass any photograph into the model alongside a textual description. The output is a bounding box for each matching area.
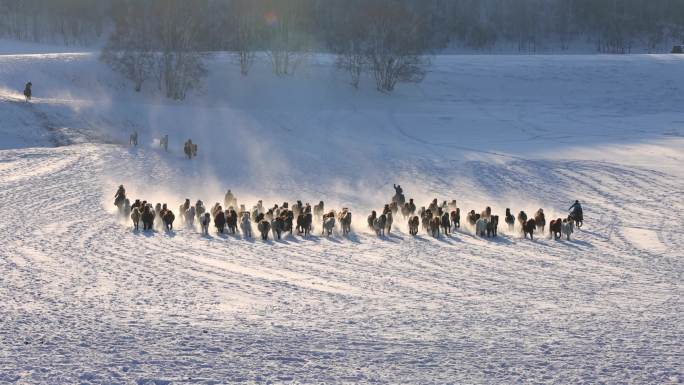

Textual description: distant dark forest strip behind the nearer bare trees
[0,0,684,53]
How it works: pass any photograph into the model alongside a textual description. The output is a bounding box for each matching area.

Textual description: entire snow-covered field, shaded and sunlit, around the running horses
[0,41,684,385]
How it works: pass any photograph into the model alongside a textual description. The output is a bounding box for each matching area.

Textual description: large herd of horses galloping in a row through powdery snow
[114,185,583,240]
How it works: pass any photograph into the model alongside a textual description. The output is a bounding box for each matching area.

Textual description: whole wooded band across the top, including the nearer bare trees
[5,0,684,99]
